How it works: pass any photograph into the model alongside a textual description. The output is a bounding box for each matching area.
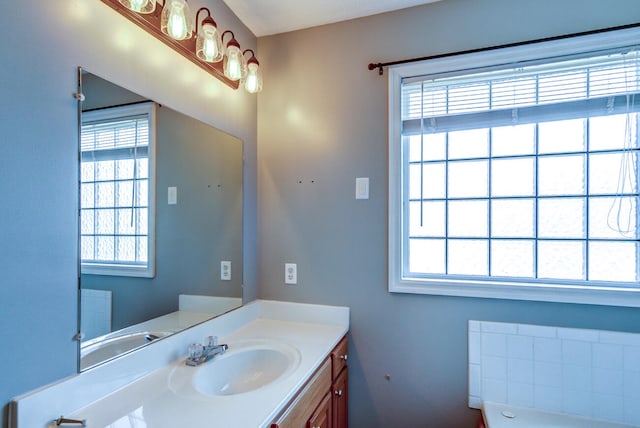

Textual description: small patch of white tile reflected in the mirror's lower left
[80,288,111,340]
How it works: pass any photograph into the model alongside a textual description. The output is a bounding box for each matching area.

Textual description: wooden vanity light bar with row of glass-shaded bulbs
[101,0,262,93]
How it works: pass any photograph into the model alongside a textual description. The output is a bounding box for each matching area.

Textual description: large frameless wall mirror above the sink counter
[78,69,243,370]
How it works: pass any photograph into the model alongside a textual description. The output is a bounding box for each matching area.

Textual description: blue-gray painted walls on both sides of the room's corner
[5,0,640,427]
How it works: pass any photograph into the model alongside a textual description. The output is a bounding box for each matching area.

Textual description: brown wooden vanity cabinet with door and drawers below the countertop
[271,337,348,428]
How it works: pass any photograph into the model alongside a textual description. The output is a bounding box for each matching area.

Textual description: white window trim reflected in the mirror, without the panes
[80,102,156,278]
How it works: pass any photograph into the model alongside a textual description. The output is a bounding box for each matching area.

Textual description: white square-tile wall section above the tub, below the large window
[468,320,640,424]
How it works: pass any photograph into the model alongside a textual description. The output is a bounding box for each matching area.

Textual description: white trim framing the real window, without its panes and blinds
[388,28,640,307]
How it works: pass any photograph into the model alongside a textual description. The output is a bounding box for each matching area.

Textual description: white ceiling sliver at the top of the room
[224,0,440,37]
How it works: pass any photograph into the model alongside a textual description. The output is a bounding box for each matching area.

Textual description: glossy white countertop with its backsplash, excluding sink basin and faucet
[10,301,349,428]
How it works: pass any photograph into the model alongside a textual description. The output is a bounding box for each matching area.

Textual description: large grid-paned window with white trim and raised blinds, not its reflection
[389,25,640,306]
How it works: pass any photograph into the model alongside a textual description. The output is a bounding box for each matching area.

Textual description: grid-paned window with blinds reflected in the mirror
[80,103,155,277]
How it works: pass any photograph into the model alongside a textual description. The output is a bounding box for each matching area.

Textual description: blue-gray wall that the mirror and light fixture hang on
[0,0,257,426]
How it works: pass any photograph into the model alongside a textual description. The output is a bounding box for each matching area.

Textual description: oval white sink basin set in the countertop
[192,342,300,395]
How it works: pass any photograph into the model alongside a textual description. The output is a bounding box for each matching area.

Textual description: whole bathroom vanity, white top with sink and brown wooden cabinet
[10,301,349,428]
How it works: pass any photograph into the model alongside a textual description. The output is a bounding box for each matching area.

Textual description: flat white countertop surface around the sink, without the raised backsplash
[71,319,345,428]
